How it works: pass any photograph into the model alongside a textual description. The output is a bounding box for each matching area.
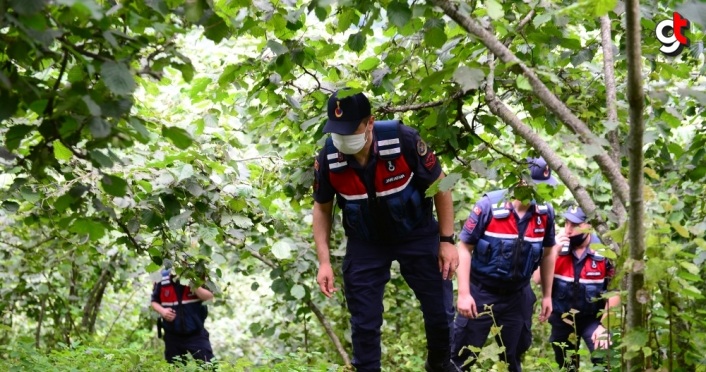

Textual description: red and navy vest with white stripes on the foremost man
[325,120,431,241]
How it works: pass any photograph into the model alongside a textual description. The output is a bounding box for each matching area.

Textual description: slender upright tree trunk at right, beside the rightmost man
[625,0,649,371]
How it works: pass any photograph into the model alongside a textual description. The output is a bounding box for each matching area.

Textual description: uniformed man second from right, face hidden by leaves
[452,158,556,371]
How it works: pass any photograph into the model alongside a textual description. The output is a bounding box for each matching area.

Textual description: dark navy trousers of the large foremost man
[343,235,454,371]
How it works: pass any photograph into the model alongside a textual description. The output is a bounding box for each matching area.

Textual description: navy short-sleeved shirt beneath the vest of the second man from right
[459,192,556,248]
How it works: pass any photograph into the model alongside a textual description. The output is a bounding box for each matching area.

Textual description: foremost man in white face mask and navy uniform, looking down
[313,92,458,371]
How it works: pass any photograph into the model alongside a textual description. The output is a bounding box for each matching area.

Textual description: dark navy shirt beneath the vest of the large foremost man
[314,125,441,238]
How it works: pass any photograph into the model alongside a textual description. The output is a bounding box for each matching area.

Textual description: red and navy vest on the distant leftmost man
[158,270,208,335]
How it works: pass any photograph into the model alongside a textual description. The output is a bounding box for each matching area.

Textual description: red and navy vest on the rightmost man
[552,247,607,316]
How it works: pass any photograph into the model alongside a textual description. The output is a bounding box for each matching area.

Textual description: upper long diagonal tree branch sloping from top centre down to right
[430,0,629,209]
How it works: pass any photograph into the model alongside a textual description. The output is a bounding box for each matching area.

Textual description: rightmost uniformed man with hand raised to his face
[549,206,620,371]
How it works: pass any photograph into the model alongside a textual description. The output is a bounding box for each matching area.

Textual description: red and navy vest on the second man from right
[471,201,549,288]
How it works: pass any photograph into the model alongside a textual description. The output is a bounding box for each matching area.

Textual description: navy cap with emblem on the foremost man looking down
[324,91,370,135]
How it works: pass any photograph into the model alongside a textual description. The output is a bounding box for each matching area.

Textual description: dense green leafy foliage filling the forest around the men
[0,0,706,370]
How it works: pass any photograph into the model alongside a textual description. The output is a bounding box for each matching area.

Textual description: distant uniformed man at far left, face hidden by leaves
[152,264,213,363]
